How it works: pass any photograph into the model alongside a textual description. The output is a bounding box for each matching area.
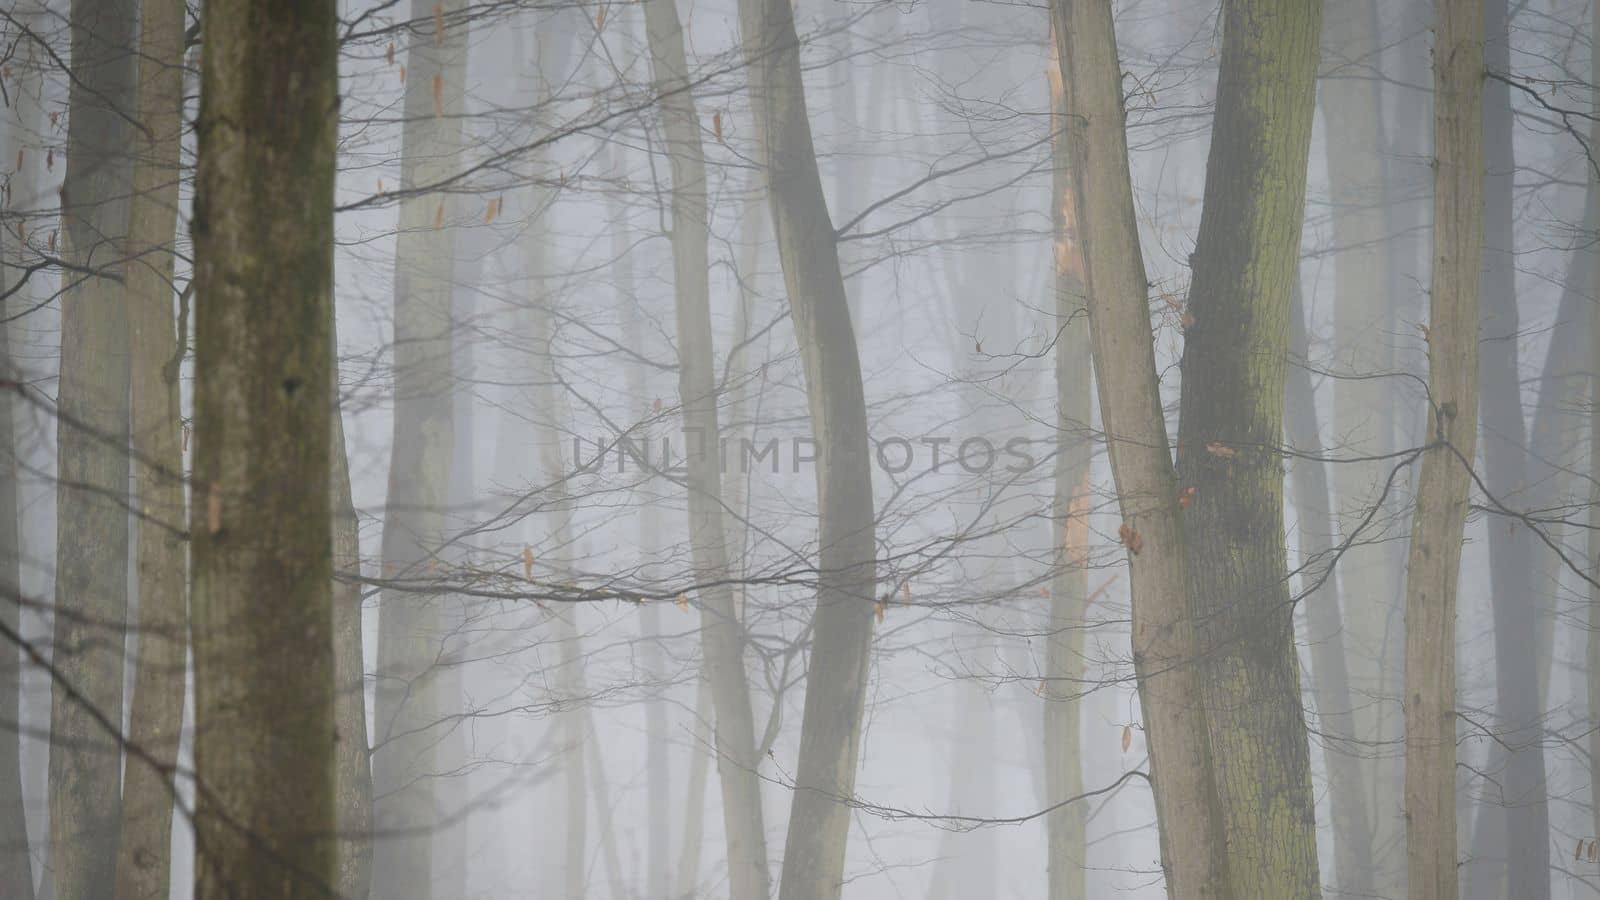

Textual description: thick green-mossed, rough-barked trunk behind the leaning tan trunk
[1178,0,1322,900]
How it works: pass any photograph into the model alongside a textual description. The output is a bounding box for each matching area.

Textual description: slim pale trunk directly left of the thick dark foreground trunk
[117,0,189,883]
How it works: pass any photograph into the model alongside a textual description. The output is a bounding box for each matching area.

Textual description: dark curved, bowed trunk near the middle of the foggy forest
[738,0,877,900]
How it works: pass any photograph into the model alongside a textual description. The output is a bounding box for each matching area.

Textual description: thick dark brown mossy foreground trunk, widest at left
[188,0,339,883]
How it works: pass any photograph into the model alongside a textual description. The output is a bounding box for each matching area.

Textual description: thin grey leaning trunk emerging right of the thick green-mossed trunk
[1283,285,1374,897]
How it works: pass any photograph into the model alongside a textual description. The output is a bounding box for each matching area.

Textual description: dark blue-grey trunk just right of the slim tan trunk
[1467,0,1550,900]
